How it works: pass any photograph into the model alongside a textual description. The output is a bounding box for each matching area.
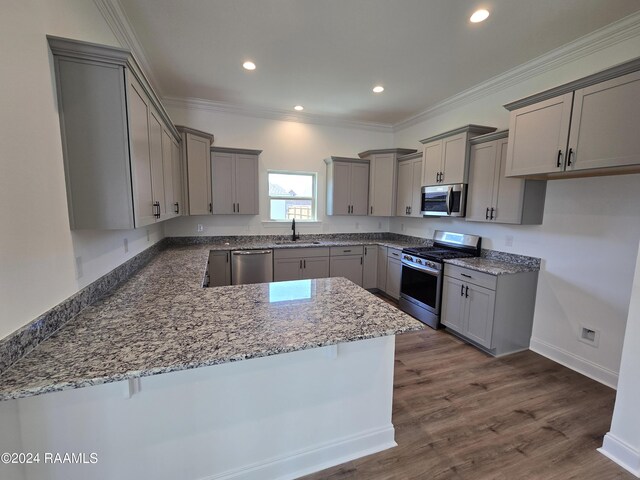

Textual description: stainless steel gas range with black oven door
[400,230,482,328]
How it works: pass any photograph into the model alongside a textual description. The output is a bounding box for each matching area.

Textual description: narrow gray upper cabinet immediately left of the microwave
[396,152,424,217]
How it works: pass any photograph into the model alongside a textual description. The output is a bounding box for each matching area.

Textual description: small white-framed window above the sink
[268,172,316,222]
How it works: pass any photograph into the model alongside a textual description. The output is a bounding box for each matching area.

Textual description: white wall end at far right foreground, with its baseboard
[601,240,640,477]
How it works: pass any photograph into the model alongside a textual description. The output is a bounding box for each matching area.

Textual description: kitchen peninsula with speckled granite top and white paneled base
[0,245,422,479]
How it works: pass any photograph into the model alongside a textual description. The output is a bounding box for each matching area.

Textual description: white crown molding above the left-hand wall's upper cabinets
[93,0,162,94]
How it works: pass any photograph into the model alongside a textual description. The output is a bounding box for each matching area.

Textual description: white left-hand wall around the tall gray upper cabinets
[0,0,163,338]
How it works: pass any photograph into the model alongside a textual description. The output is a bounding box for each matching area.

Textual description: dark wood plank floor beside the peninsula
[304,300,635,480]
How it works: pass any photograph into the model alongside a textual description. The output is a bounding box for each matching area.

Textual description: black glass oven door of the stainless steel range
[400,263,442,315]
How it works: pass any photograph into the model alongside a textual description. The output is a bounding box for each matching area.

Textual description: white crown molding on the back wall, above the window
[162,97,393,133]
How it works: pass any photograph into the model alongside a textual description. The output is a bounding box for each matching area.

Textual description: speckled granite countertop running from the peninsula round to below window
[0,246,424,400]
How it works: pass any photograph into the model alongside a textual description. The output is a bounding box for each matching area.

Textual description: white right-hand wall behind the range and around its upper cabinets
[390,31,640,386]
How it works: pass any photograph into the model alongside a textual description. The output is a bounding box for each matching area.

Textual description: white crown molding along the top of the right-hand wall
[393,12,640,132]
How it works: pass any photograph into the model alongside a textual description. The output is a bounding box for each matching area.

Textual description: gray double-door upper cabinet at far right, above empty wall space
[505,59,640,178]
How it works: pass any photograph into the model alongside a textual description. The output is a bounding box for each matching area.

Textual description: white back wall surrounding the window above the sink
[165,105,393,236]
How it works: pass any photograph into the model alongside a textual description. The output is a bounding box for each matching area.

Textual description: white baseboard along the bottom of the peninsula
[201,425,398,480]
